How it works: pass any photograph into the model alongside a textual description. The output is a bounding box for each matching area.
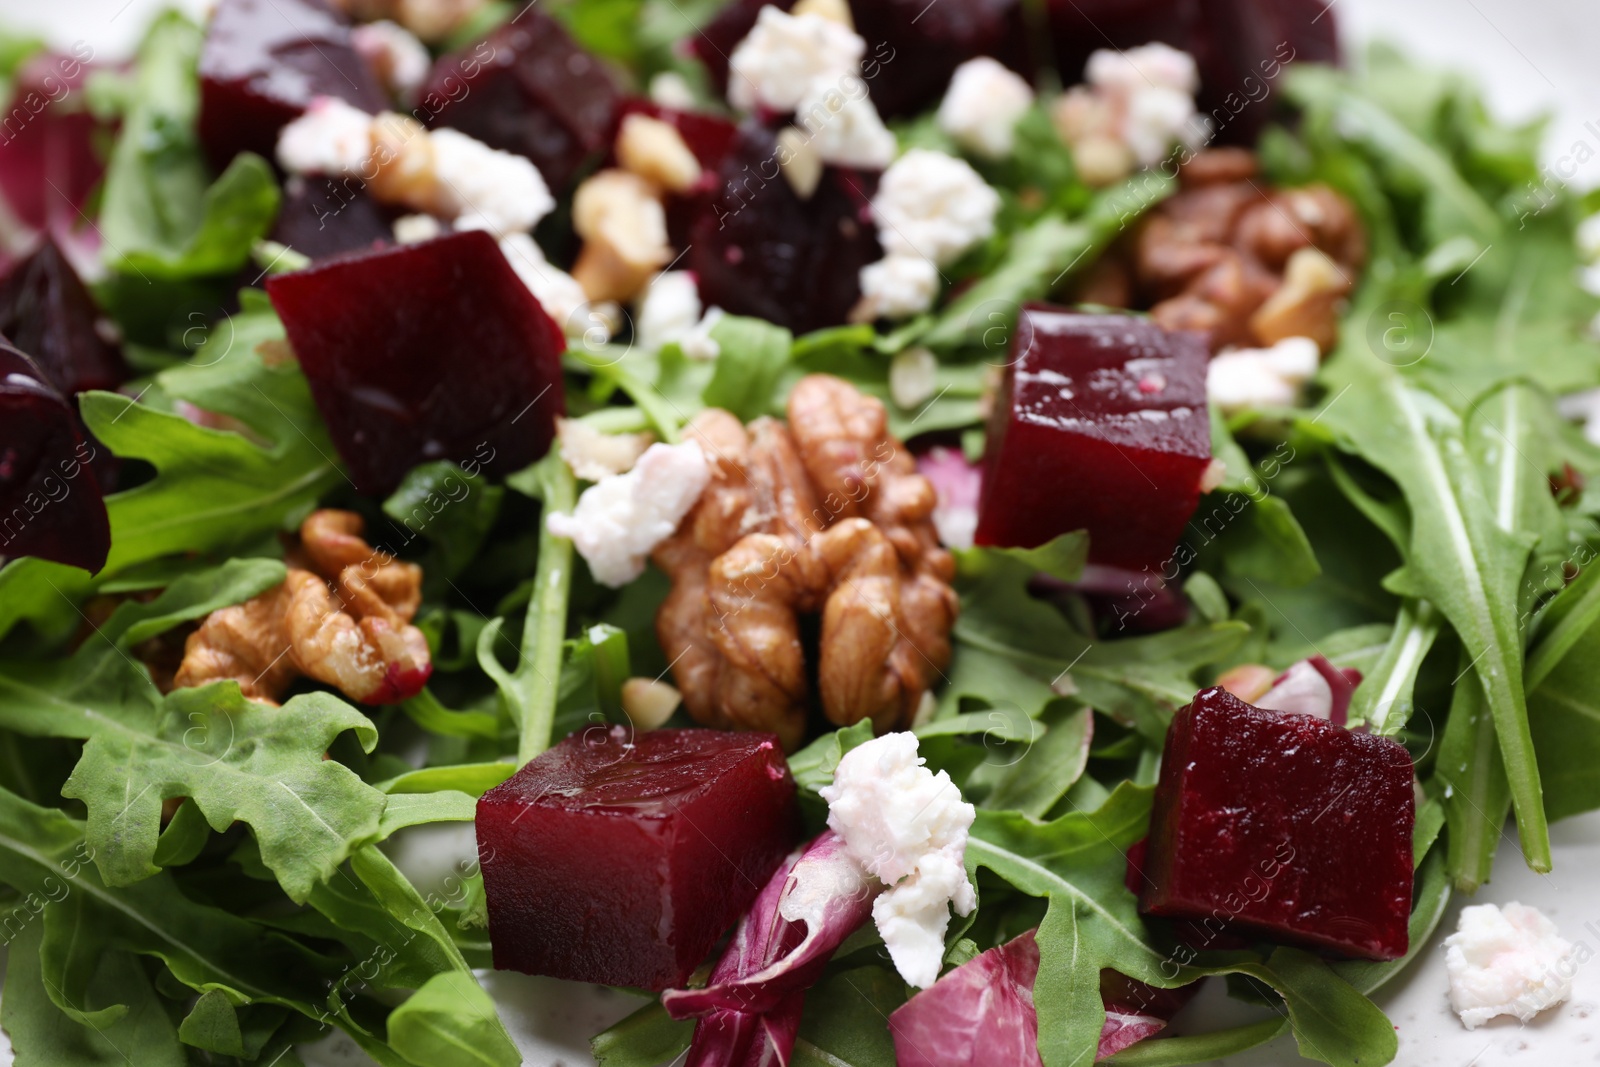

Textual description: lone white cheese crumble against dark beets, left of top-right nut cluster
[1083,43,1208,166]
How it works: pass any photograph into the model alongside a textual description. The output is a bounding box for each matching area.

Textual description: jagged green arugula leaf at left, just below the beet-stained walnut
[0,560,384,901]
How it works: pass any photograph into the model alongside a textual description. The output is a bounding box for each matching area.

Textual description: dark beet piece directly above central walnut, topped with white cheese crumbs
[683,122,883,333]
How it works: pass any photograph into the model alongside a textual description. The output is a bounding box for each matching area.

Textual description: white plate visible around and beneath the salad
[0,0,1600,1067]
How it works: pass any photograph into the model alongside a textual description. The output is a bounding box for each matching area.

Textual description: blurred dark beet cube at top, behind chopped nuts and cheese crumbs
[421,15,622,195]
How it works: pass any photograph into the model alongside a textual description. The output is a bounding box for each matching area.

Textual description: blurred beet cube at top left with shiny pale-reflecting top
[200,0,389,170]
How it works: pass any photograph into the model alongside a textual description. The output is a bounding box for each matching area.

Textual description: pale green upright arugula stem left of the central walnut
[512,448,578,765]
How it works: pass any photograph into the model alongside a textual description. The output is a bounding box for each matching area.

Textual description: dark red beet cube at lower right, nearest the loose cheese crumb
[1139,688,1416,960]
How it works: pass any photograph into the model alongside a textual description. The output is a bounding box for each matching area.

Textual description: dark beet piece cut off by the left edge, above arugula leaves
[0,338,110,571]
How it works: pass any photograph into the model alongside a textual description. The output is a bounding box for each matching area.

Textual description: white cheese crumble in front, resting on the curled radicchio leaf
[821,733,978,989]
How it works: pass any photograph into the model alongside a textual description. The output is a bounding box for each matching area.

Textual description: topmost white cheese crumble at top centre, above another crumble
[728,5,867,112]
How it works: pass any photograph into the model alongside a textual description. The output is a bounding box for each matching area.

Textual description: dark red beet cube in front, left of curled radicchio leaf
[477,726,800,990]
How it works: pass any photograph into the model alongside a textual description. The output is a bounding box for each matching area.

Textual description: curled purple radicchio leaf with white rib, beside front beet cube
[661,830,880,1067]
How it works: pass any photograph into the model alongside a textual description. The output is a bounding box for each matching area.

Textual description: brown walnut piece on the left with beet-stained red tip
[173,509,434,704]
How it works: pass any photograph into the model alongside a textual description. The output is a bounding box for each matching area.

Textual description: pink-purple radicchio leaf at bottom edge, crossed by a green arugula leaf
[890,929,1198,1067]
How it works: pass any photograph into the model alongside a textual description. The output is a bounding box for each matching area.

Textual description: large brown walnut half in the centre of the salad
[653,374,957,749]
